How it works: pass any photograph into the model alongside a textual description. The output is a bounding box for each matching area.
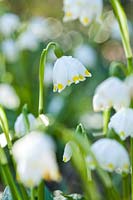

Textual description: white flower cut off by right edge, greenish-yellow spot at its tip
[109,108,133,140]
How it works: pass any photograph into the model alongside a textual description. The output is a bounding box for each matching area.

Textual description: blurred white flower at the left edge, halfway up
[0,83,20,109]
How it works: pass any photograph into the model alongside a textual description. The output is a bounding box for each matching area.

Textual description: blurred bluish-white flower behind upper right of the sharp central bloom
[74,44,96,67]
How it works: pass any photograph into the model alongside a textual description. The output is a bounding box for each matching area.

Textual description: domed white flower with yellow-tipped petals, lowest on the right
[88,138,130,173]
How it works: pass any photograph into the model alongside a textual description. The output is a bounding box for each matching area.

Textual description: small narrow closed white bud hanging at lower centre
[63,142,72,162]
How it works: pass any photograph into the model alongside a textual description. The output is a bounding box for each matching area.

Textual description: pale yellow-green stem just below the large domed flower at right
[103,109,110,135]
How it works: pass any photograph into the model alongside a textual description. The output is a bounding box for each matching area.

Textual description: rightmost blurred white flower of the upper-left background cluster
[27,17,47,41]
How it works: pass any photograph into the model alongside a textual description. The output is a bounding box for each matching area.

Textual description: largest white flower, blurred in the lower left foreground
[12,132,60,187]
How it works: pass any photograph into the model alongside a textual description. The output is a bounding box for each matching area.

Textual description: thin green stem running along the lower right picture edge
[130,137,133,200]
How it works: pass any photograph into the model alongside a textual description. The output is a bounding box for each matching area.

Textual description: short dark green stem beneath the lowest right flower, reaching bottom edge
[122,174,130,200]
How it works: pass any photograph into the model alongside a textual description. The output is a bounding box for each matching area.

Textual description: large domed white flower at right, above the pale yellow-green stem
[93,77,130,111]
